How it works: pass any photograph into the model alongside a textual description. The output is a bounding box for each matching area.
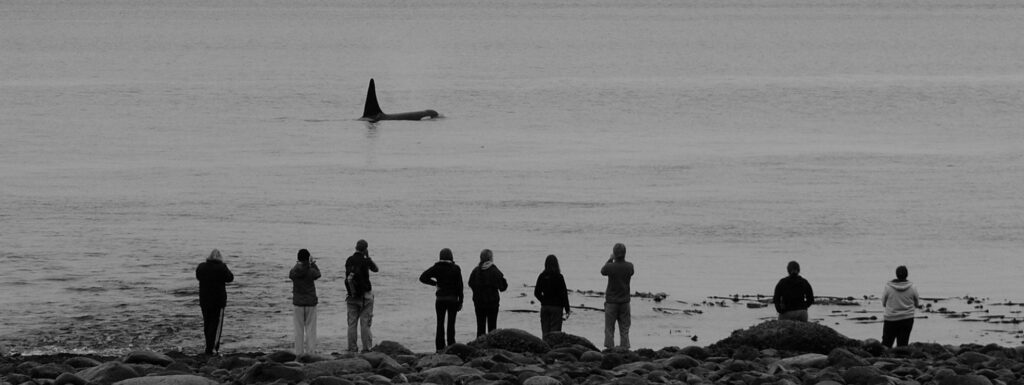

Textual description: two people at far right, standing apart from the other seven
[772,261,921,347]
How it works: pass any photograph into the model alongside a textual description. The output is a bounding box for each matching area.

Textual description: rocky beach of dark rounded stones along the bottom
[0,320,1024,385]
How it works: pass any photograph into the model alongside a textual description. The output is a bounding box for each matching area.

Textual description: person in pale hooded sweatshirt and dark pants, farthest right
[882,266,920,347]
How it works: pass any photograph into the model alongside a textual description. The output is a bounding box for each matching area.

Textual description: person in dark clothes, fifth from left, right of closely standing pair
[469,249,509,337]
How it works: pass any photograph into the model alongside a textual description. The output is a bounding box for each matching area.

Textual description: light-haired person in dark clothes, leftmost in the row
[196,249,234,355]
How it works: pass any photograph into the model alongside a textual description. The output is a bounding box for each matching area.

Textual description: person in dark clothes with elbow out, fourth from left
[420,248,463,351]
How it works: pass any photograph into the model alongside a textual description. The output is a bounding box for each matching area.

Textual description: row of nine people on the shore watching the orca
[196,240,920,354]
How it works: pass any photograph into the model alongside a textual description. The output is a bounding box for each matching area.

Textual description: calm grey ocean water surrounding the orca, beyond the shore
[0,0,1024,351]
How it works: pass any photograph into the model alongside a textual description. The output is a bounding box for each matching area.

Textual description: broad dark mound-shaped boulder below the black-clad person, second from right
[711,320,859,354]
